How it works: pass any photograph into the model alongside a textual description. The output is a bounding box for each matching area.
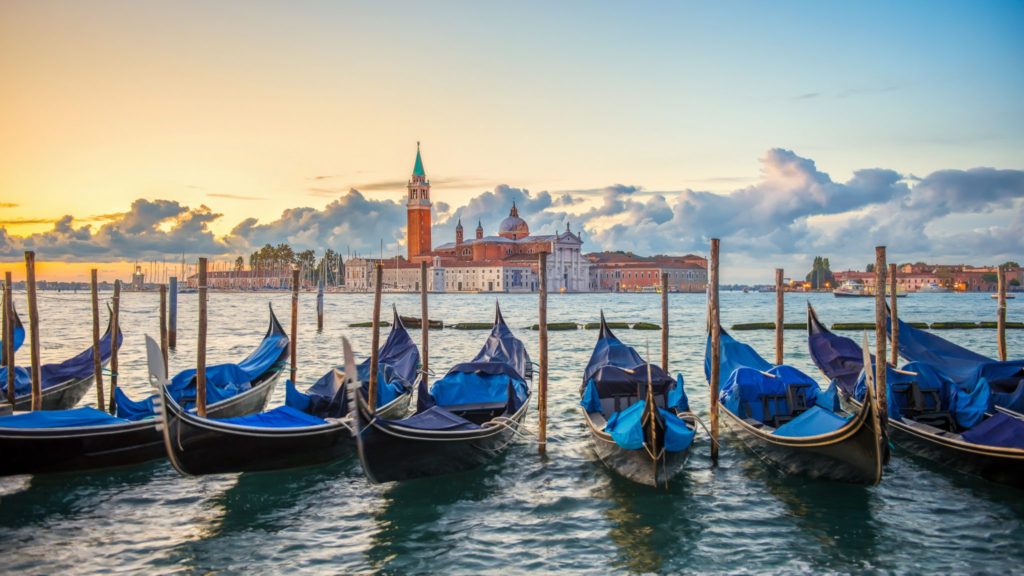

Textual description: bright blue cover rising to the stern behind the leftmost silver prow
[118,310,288,419]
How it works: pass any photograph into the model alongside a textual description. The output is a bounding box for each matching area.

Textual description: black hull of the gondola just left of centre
[359,396,532,484]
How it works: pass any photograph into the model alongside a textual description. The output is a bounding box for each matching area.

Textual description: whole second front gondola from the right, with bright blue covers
[705,330,886,485]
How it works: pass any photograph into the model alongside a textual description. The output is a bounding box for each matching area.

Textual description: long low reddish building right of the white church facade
[587,252,708,292]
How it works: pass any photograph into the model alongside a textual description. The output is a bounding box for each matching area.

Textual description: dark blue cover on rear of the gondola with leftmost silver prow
[298,310,420,412]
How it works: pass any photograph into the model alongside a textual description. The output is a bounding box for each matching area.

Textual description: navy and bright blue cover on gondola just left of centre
[417,304,532,412]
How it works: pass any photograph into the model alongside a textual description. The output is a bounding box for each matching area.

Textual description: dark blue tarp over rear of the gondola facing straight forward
[581,313,689,416]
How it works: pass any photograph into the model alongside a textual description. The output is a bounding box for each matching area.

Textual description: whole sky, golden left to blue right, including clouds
[0,0,1024,283]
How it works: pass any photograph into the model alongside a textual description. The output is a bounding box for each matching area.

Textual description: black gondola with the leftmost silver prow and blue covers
[158,312,420,475]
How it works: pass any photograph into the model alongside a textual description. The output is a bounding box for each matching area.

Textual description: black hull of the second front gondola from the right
[719,393,885,485]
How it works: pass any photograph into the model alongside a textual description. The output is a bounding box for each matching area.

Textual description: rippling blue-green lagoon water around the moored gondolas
[0,293,1024,574]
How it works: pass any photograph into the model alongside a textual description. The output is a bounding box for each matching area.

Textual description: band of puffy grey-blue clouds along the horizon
[0,149,1024,281]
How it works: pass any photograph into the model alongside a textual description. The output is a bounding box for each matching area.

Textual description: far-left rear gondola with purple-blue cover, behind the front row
[0,307,124,411]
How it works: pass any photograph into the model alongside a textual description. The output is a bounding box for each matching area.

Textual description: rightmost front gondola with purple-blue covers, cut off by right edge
[807,304,1024,488]
